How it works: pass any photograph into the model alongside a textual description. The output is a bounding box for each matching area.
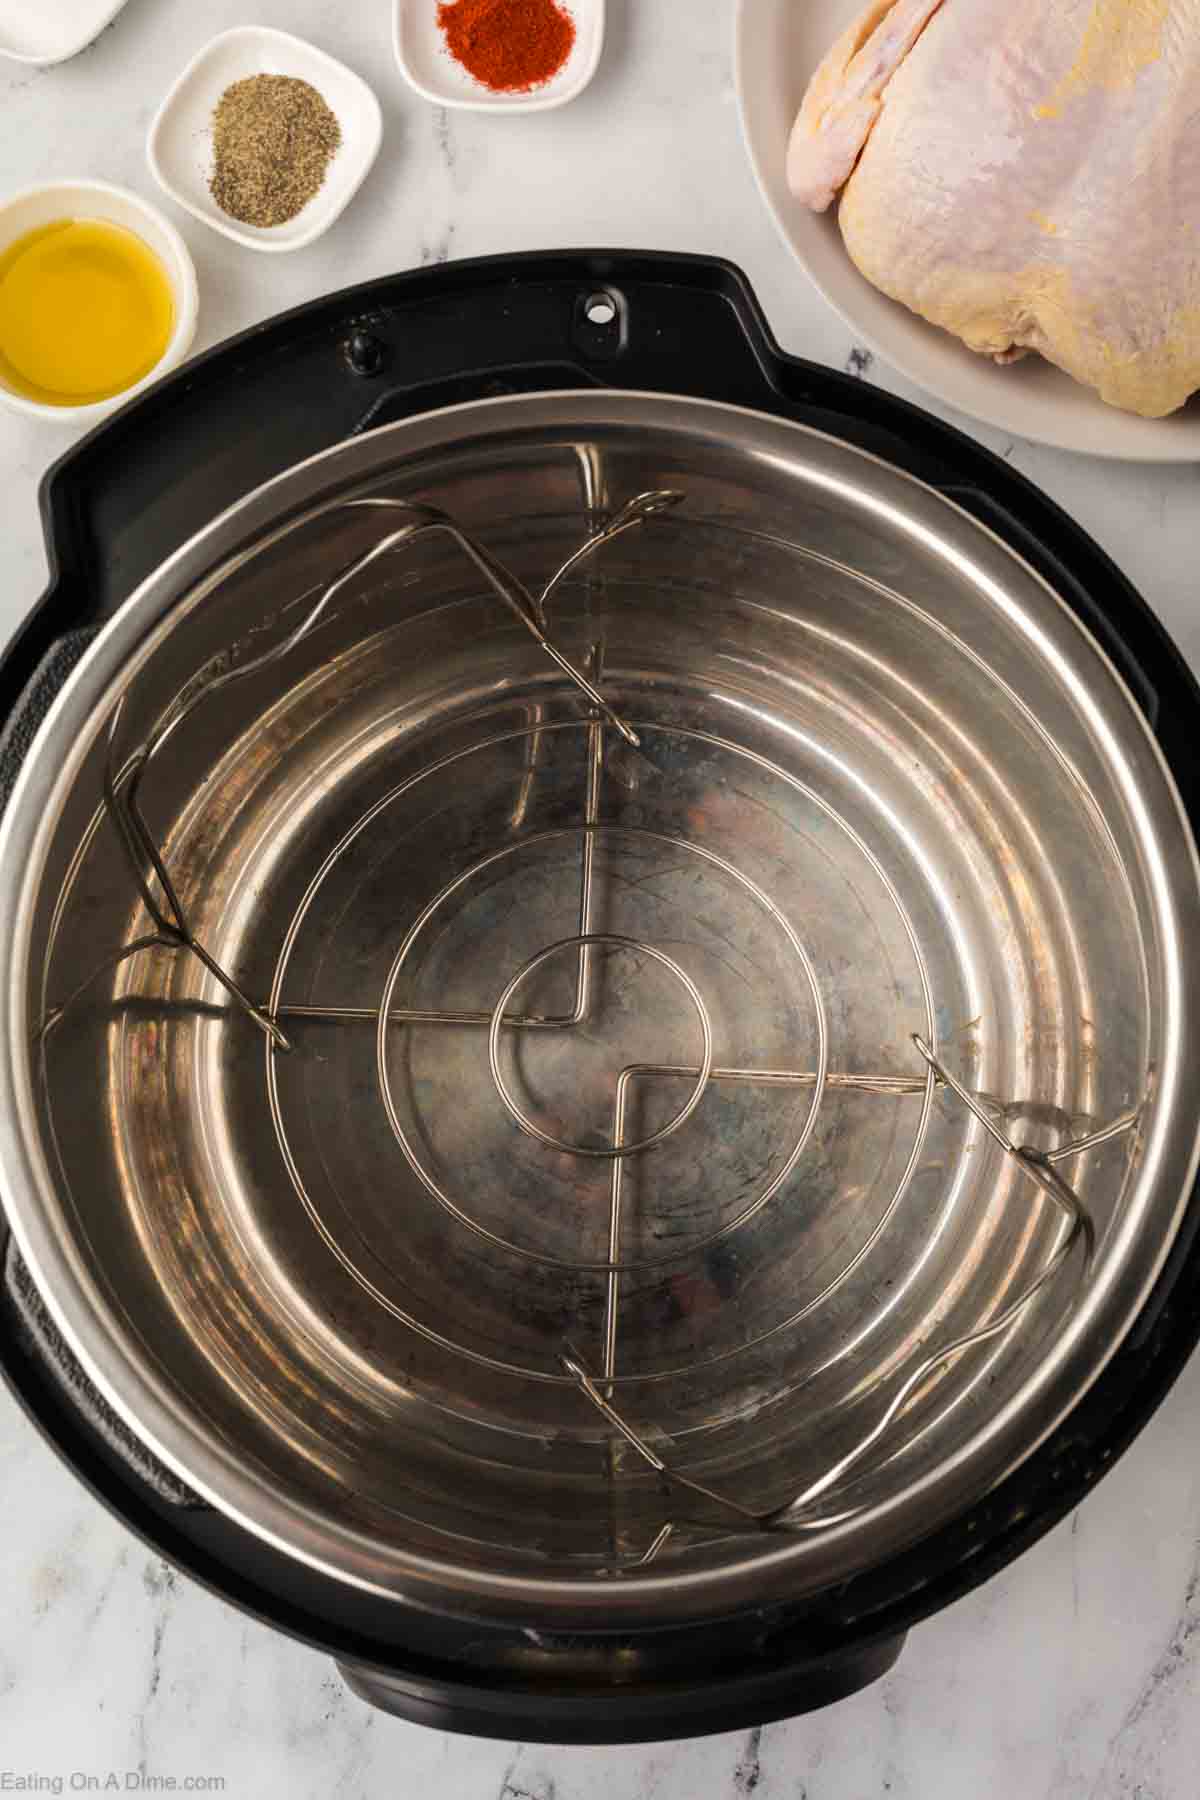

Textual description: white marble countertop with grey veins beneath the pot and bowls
[0,0,1200,1800]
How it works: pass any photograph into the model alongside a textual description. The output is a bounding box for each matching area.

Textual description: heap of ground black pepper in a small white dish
[209,76,342,225]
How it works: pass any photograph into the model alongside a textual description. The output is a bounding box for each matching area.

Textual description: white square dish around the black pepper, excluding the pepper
[146,25,383,252]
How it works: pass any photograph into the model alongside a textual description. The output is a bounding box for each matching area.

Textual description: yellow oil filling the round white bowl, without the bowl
[0,220,175,407]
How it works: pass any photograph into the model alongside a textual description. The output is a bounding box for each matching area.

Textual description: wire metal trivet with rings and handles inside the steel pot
[51,490,1141,1566]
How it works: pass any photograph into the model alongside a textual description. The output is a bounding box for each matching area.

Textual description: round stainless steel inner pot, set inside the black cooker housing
[0,394,1200,1625]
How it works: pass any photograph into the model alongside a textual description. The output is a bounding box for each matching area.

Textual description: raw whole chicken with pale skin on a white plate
[788,0,1200,418]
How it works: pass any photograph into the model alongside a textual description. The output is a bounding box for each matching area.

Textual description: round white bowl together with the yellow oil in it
[0,182,196,425]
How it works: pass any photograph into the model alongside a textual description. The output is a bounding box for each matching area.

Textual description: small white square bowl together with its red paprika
[394,0,604,112]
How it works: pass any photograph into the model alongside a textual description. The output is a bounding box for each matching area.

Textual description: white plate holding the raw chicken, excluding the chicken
[734,0,1200,463]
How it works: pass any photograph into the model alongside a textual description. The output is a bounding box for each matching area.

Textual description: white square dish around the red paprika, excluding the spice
[392,0,604,113]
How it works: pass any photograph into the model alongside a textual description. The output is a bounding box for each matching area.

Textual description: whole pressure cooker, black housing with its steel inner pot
[0,252,1200,1742]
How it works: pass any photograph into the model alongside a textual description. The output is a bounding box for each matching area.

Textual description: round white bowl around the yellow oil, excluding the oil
[0,182,198,425]
